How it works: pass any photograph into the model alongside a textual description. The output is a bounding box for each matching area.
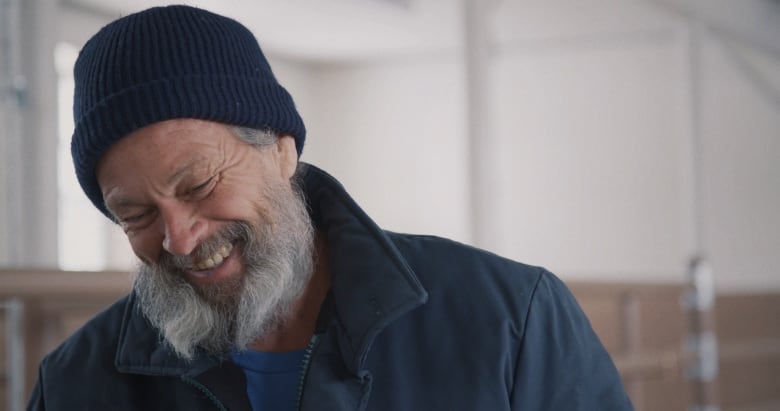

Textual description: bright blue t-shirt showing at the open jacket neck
[231,350,306,411]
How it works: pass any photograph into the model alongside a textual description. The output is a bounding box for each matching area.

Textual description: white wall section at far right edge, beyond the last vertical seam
[702,37,780,291]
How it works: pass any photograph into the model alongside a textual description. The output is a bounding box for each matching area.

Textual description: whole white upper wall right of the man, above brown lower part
[292,5,780,291]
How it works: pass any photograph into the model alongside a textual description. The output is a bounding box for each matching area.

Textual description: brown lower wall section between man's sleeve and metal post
[569,282,690,411]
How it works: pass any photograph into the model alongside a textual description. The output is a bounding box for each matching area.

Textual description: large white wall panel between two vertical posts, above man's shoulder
[495,38,691,280]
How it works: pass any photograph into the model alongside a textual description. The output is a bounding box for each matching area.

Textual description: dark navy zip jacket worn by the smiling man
[29,166,632,411]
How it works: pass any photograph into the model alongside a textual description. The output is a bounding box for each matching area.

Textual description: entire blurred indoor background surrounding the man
[0,0,780,411]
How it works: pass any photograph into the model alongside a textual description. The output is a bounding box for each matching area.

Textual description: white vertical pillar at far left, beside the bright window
[11,0,58,267]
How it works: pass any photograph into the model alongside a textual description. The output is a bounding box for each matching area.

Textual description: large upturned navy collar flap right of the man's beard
[303,164,428,374]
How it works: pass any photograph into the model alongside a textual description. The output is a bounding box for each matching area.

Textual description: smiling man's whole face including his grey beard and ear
[97,119,312,357]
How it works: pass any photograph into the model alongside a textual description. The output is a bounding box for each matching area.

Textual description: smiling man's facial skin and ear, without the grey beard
[97,119,296,272]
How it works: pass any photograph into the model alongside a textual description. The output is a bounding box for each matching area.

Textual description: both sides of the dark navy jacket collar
[116,163,428,375]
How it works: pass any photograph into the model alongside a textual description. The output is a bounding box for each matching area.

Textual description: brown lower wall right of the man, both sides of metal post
[569,283,780,411]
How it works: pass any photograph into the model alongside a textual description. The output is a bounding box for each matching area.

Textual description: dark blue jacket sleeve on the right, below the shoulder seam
[511,272,633,411]
